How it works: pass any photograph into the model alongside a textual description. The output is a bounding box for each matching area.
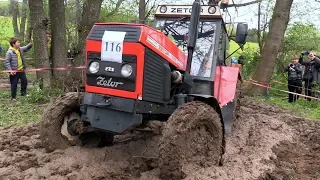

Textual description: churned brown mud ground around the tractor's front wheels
[0,98,320,180]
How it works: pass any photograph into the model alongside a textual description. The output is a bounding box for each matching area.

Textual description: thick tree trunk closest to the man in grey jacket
[29,0,51,88]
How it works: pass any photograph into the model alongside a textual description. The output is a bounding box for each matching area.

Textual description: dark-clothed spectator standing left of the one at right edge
[284,56,302,103]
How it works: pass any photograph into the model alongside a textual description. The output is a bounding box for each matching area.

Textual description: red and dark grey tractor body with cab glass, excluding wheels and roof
[82,18,238,134]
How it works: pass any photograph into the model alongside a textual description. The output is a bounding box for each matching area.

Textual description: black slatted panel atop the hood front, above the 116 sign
[87,25,141,42]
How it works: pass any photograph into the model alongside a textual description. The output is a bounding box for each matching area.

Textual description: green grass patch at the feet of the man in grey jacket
[0,91,42,127]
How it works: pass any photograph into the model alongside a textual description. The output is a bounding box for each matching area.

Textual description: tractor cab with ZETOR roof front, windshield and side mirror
[153,5,247,95]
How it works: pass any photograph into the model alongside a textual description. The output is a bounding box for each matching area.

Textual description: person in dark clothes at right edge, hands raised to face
[299,52,320,101]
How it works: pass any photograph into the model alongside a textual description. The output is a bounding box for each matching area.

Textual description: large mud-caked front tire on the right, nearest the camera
[159,101,223,180]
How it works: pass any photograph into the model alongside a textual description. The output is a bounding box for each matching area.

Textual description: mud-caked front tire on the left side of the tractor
[40,93,83,152]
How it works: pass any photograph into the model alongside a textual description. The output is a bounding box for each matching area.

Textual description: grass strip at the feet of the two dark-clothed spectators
[254,96,320,120]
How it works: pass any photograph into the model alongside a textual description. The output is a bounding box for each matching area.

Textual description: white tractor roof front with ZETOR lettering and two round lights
[155,5,222,19]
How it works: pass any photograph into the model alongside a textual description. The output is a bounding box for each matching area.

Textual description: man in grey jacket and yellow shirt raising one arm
[5,37,32,100]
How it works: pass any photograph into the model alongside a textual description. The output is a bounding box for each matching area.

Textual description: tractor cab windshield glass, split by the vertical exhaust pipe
[155,18,217,77]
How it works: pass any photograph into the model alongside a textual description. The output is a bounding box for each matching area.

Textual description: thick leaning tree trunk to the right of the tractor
[248,0,293,95]
